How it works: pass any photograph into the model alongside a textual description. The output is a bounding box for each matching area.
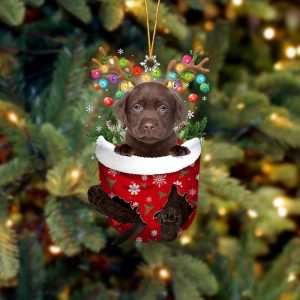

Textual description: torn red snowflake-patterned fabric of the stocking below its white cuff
[99,157,200,243]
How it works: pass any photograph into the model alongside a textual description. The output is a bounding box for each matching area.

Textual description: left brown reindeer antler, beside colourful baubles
[92,47,136,85]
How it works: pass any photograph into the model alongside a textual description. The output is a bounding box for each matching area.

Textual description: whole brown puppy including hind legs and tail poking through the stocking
[88,82,190,245]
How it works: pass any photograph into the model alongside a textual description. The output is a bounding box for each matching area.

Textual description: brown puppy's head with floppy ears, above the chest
[114,82,187,144]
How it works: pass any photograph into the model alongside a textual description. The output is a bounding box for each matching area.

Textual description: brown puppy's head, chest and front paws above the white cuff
[114,82,190,157]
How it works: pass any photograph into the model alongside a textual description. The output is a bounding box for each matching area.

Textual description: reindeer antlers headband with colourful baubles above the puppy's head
[91,47,209,106]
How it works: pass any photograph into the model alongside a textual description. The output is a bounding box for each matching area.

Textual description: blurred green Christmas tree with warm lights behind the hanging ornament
[0,0,300,300]
